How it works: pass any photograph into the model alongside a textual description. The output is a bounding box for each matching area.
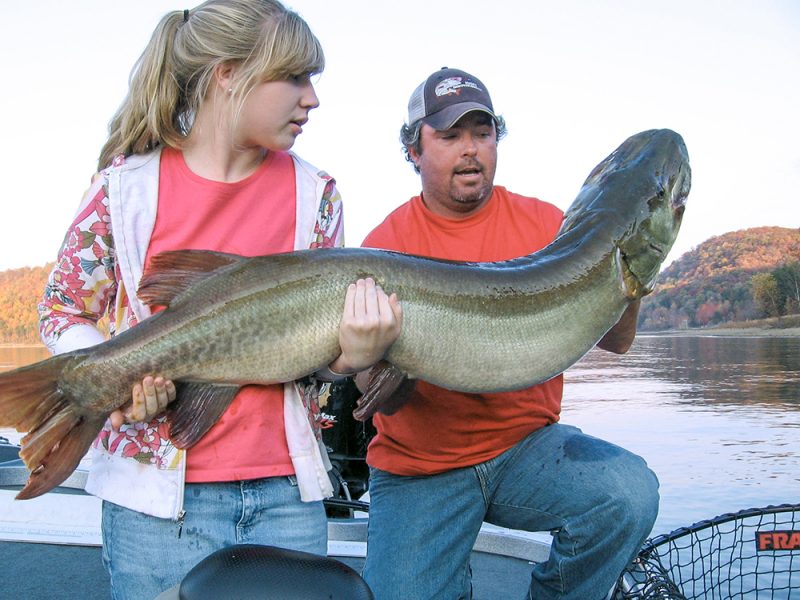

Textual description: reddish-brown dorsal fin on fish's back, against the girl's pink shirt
[136,250,244,306]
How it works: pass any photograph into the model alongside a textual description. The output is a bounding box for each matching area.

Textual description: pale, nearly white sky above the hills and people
[0,0,800,270]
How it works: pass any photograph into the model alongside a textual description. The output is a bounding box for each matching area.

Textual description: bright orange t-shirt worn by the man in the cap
[362,186,563,475]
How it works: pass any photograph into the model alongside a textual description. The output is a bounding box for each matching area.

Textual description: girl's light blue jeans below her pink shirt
[102,477,328,600]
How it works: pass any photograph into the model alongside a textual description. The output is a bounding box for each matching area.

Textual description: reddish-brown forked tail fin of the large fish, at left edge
[0,354,105,500]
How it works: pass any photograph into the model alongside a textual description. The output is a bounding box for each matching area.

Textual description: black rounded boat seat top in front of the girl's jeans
[156,544,374,600]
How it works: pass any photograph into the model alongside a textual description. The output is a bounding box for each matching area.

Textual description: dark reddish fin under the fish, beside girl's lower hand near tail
[167,381,239,448]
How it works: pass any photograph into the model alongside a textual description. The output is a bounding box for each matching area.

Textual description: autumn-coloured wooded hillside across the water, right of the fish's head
[639,227,800,331]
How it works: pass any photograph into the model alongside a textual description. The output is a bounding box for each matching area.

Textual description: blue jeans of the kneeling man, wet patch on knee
[363,424,658,600]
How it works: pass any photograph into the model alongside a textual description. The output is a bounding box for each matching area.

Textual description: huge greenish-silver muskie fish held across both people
[0,129,690,498]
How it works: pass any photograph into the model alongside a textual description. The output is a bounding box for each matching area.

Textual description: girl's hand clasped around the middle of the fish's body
[330,277,403,373]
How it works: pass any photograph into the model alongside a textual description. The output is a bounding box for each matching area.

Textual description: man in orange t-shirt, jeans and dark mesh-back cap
[363,68,658,600]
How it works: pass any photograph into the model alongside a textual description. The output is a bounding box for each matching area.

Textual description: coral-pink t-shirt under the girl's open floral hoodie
[146,148,296,482]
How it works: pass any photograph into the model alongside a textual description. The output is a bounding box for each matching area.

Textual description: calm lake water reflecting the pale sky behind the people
[0,336,800,534]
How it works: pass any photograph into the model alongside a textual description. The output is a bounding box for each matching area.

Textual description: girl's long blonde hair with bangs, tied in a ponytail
[98,0,325,170]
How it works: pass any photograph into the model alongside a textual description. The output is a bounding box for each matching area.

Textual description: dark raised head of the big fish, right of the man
[562,129,691,299]
